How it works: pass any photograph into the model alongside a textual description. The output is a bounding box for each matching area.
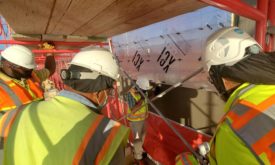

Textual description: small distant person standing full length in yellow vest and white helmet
[126,78,152,161]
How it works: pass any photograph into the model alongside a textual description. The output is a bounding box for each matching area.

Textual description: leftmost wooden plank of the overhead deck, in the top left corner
[0,0,54,34]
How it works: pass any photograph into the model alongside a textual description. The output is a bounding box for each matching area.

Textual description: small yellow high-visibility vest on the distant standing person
[127,91,148,121]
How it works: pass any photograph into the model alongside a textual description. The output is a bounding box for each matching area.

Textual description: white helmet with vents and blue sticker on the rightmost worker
[203,27,261,70]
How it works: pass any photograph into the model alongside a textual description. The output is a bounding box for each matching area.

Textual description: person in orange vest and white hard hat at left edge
[0,45,55,116]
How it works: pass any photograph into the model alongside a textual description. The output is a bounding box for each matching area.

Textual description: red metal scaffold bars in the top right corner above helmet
[200,0,275,51]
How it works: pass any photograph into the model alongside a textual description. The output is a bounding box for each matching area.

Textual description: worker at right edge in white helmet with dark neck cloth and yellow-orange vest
[177,27,275,165]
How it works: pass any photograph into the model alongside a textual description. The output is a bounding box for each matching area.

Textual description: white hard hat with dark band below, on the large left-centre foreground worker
[70,48,119,80]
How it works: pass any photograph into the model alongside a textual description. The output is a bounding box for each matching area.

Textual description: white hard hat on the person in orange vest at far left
[1,45,36,69]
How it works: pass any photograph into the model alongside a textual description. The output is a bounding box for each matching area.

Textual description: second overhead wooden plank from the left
[47,0,115,36]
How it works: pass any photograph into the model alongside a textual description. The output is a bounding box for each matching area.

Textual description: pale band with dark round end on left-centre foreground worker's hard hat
[60,69,100,80]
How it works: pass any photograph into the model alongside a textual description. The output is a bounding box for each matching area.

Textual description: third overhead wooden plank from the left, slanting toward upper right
[73,0,184,35]
